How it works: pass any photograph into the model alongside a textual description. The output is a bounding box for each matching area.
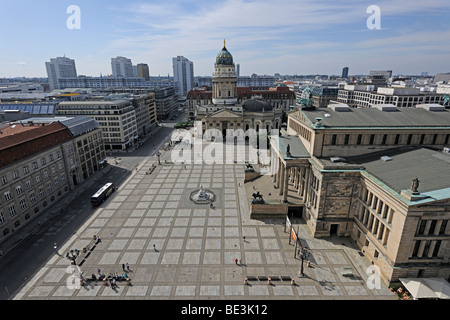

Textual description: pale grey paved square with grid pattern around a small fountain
[12,142,395,300]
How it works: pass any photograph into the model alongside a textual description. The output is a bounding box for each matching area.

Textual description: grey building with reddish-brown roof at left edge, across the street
[0,122,75,241]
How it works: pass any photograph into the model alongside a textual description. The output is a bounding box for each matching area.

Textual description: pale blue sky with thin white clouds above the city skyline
[0,0,450,78]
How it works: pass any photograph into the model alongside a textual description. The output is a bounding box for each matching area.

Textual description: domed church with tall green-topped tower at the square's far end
[192,44,282,140]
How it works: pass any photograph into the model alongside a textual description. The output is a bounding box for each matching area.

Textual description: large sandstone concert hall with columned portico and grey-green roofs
[271,105,450,282]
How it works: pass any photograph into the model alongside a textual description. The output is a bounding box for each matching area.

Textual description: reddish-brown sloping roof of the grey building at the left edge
[0,122,73,168]
